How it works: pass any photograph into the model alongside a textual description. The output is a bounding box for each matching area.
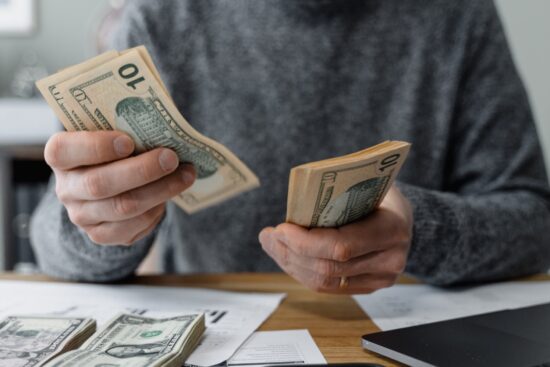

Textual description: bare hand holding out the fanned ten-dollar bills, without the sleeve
[45,131,195,245]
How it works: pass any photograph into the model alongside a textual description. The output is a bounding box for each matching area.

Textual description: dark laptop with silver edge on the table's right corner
[362,304,550,367]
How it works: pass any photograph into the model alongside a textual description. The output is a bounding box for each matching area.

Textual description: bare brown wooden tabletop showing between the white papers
[0,273,550,367]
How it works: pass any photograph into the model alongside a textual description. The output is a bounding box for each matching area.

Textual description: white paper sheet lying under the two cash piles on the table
[0,281,285,366]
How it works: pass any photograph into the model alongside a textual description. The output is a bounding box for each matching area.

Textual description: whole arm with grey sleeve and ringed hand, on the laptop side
[260,1,550,293]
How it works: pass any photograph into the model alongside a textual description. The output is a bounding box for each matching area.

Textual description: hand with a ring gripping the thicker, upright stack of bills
[260,186,413,293]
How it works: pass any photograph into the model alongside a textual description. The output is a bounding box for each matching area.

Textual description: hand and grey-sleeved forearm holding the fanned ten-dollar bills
[31,131,194,281]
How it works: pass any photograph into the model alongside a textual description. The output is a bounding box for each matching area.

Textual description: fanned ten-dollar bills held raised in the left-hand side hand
[37,46,259,213]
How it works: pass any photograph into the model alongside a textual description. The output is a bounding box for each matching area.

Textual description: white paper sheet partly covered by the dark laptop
[353,281,550,330]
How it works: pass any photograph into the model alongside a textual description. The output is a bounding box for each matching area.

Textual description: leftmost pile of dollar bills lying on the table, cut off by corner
[0,316,96,367]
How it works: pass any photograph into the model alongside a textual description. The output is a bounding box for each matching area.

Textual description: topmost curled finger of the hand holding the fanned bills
[44,131,135,170]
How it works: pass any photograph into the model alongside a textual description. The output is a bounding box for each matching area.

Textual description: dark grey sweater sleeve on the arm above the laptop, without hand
[400,1,550,285]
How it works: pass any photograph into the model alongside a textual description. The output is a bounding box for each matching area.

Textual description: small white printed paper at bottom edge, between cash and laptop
[227,330,327,367]
